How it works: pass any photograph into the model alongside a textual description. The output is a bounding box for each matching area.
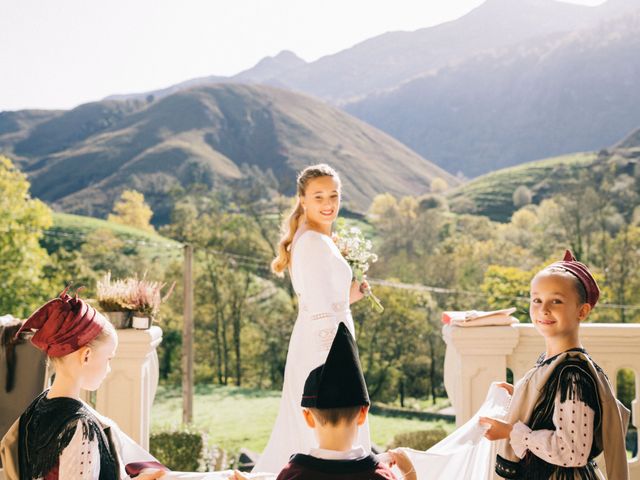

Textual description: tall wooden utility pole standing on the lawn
[182,244,193,425]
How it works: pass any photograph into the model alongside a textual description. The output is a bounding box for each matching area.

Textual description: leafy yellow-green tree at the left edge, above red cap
[0,156,52,317]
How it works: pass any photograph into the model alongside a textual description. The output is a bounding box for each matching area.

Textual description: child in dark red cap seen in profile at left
[0,289,164,480]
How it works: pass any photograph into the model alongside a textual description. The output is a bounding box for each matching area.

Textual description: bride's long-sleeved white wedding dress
[253,230,371,474]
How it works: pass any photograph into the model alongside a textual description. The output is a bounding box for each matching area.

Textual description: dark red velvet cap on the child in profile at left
[16,287,107,357]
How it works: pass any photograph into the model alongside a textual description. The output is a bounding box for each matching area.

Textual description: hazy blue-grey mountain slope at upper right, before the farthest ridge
[344,10,640,177]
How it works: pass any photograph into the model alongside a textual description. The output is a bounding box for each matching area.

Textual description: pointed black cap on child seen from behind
[300,322,371,409]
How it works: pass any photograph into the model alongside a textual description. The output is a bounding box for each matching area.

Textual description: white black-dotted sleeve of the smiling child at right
[509,394,595,467]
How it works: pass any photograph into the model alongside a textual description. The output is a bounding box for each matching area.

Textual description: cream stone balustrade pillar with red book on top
[442,325,518,427]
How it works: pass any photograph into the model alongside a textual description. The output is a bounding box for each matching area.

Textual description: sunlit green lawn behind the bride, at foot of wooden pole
[151,385,454,452]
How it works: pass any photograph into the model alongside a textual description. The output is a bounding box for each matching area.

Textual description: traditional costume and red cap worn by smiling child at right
[496,251,629,480]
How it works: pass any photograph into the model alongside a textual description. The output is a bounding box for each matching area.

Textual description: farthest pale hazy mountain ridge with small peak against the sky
[108,0,637,105]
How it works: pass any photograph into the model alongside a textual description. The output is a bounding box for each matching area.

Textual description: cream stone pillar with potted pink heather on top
[96,326,162,450]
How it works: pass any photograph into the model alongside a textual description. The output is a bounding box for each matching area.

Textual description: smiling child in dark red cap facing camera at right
[480,250,629,480]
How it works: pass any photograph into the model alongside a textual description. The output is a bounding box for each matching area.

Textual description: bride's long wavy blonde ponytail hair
[271,163,341,276]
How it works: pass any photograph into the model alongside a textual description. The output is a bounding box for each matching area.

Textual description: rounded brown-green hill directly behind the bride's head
[0,84,459,221]
